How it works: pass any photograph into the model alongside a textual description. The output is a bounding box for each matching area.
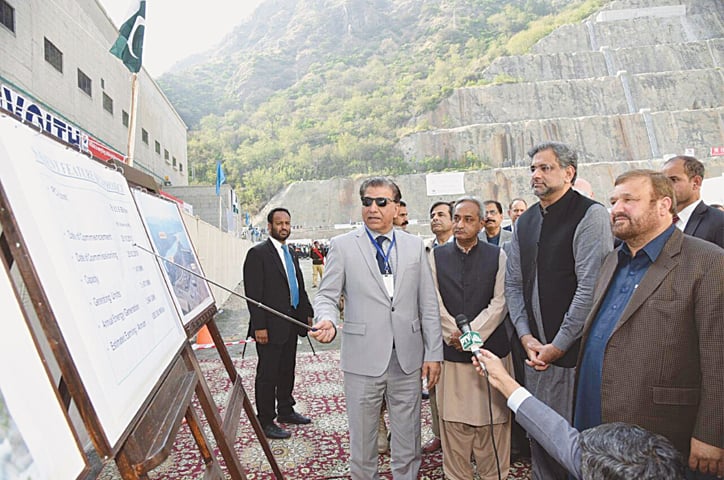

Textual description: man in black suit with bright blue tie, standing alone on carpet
[244,208,314,439]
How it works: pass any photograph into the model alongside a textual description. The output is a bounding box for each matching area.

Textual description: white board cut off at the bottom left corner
[0,264,85,480]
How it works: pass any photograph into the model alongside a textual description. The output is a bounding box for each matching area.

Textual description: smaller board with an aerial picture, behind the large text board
[133,190,214,325]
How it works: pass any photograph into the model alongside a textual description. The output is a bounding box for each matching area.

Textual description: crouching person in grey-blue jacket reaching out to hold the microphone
[473,350,684,480]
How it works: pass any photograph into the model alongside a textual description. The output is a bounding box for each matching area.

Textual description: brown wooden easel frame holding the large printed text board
[0,185,232,480]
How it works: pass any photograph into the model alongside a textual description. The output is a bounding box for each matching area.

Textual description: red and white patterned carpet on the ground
[98,351,529,480]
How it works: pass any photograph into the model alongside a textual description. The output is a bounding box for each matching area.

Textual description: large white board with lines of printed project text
[0,118,186,446]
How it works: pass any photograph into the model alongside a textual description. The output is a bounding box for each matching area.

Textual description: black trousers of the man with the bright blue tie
[254,331,297,427]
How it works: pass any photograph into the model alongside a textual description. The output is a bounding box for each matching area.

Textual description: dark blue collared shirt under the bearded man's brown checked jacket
[574,225,674,431]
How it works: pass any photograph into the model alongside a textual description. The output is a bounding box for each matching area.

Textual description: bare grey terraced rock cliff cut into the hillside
[259,0,724,231]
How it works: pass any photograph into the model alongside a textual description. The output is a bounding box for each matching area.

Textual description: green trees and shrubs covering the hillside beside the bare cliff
[160,0,605,211]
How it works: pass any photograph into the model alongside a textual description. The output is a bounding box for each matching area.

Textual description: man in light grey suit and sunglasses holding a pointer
[310,177,443,480]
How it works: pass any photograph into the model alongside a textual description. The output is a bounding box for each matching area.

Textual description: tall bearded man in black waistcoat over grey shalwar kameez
[505,142,613,480]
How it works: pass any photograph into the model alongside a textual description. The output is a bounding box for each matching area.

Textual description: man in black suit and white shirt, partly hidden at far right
[664,155,724,248]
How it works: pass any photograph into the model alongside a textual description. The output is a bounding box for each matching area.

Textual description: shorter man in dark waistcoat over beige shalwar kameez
[431,197,513,480]
